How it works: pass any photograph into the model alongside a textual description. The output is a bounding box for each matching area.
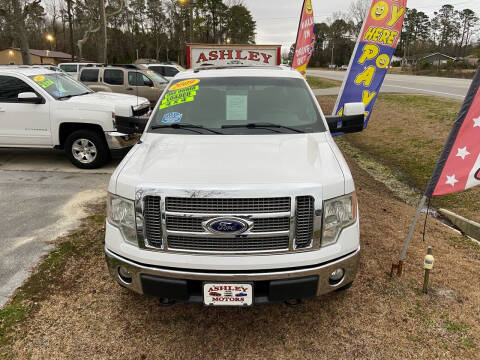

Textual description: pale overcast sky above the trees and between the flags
[244,0,480,51]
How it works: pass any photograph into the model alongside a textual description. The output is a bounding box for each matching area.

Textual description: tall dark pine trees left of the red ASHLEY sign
[0,0,256,63]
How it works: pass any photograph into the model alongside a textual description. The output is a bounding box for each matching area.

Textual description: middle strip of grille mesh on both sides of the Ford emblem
[167,215,290,233]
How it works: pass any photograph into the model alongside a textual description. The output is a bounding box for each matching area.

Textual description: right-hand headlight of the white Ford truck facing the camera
[322,192,357,246]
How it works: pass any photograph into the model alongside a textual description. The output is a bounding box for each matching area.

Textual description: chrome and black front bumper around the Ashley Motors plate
[105,248,360,304]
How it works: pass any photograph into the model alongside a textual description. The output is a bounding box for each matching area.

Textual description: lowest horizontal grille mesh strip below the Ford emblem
[168,235,289,252]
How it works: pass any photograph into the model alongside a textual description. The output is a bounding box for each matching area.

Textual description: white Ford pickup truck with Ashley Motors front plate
[105,67,365,306]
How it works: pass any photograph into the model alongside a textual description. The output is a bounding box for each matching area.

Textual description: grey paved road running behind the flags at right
[307,70,472,100]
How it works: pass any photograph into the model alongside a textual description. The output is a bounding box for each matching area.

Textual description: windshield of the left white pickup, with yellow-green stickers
[30,73,93,100]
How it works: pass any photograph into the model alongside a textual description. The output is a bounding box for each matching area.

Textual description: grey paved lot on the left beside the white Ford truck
[0,149,116,307]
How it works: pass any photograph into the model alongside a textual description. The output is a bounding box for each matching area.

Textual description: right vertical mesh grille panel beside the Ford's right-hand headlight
[295,196,314,249]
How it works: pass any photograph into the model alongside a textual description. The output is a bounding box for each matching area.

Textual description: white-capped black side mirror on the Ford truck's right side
[325,102,365,135]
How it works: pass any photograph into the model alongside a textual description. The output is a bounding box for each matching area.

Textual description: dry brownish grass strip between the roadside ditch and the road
[317,95,480,222]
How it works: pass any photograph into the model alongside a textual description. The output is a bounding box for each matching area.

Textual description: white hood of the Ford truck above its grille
[111,133,345,198]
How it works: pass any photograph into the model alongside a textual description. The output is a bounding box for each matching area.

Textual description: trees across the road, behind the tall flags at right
[289,0,480,67]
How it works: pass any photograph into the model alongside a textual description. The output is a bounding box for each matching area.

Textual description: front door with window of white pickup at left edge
[0,75,53,146]
